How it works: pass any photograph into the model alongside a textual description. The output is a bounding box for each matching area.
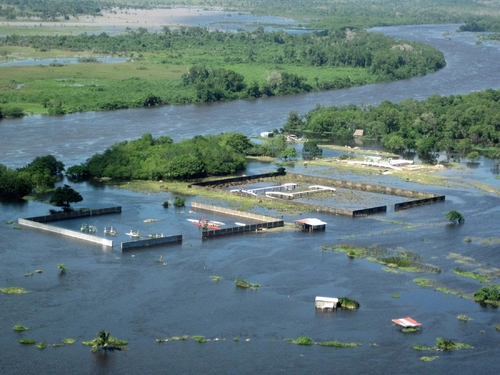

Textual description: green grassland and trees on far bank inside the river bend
[0,27,445,117]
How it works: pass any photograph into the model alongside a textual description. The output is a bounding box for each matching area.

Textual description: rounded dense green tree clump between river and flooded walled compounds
[66,133,292,180]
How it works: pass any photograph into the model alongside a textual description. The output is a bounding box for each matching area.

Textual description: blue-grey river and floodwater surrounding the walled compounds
[0,26,500,374]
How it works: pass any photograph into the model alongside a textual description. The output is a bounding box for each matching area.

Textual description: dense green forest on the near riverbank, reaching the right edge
[283,90,500,161]
